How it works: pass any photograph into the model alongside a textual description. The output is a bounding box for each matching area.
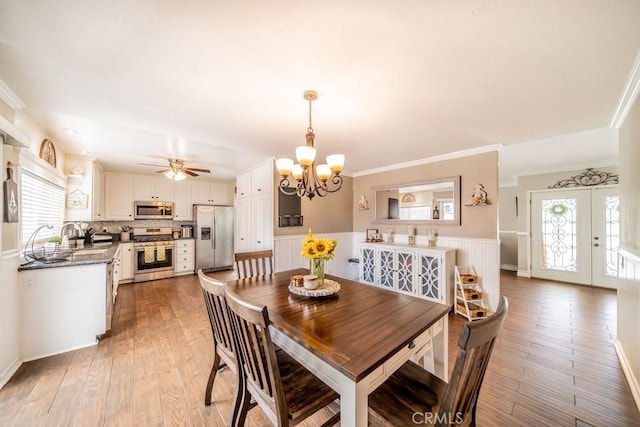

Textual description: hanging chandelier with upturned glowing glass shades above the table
[276,90,344,200]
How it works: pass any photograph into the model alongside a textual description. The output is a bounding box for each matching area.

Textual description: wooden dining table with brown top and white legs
[229,269,450,427]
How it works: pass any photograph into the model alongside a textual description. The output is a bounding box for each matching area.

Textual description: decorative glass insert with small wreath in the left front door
[540,198,578,272]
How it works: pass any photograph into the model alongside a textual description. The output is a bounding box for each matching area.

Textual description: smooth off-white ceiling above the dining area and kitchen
[0,0,640,182]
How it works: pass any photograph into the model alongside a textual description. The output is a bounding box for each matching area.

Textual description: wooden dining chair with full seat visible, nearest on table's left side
[225,284,340,427]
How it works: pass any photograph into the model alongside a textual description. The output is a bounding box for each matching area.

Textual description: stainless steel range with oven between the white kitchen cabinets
[133,227,175,282]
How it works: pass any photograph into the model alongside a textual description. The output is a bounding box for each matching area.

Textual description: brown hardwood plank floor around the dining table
[0,272,640,426]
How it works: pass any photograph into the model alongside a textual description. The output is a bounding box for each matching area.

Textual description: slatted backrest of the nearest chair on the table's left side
[225,285,288,424]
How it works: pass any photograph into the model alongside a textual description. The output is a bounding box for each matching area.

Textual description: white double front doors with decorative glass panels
[531,186,620,288]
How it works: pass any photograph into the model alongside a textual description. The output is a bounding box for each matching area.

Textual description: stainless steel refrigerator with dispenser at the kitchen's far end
[193,205,234,271]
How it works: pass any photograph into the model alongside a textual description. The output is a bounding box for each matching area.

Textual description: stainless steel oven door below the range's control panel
[133,246,175,282]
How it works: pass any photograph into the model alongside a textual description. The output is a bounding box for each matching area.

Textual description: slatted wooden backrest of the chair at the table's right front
[438,296,509,425]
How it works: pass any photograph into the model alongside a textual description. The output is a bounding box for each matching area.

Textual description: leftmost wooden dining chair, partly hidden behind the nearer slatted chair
[198,269,244,406]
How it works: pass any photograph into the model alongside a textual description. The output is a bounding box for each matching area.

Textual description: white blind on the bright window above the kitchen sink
[20,169,64,246]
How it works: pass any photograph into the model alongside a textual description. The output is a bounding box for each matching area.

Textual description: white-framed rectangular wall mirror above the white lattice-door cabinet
[373,176,460,225]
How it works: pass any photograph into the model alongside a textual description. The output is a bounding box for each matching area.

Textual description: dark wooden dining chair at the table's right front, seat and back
[369,296,509,426]
